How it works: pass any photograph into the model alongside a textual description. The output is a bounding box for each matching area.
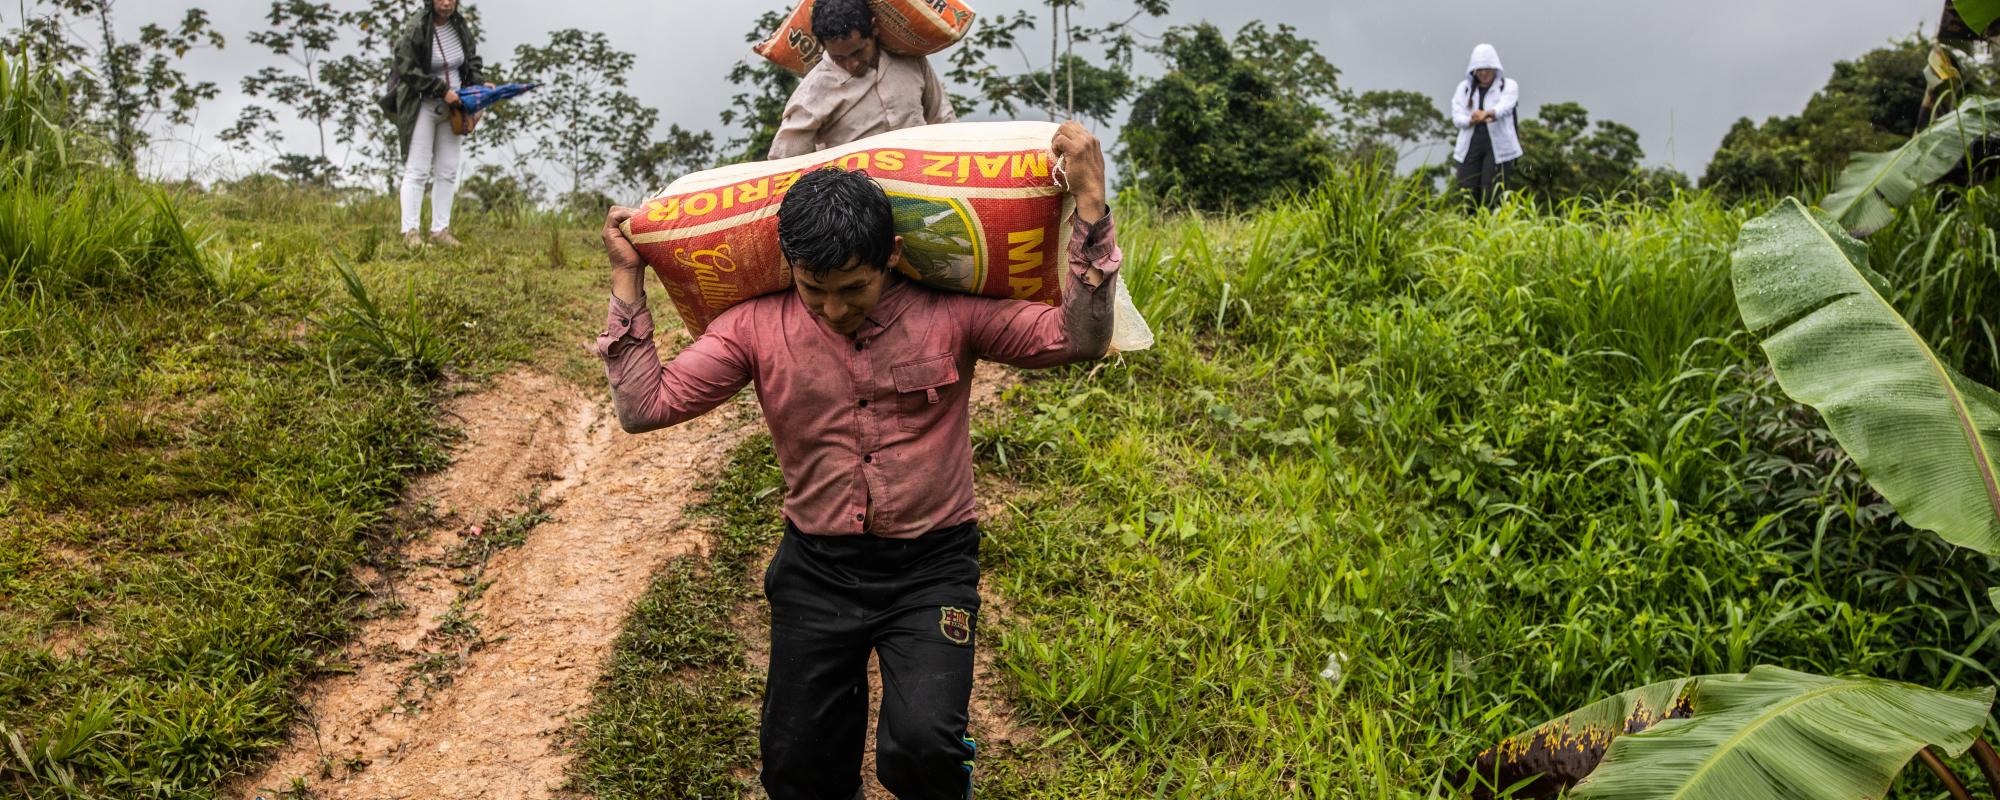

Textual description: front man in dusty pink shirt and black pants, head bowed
[592,122,1120,800]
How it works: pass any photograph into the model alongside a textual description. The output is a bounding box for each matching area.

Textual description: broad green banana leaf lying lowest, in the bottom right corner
[1570,666,1994,800]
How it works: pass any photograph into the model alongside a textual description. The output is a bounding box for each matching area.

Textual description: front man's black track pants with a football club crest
[760,522,980,800]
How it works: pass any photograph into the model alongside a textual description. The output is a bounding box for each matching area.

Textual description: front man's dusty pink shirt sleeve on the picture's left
[590,294,752,434]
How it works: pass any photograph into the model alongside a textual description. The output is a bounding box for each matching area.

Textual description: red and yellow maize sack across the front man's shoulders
[624,122,1152,350]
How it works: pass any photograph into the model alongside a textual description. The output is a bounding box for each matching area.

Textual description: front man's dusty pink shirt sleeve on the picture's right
[960,214,1124,368]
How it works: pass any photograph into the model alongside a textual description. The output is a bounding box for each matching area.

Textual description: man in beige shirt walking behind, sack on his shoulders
[770,0,958,158]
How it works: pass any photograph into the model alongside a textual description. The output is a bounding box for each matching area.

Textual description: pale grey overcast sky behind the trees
[31,0,1942,188]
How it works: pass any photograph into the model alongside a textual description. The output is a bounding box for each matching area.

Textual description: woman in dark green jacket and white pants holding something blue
[384,0,492,248]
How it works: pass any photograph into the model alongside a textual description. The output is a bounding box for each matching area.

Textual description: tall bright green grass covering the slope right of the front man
[976,170,2000,798]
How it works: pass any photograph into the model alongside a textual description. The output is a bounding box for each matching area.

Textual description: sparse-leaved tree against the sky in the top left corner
[6,0,224,170]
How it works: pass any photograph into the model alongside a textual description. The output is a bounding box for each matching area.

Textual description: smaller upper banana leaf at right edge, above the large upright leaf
[1820,98,2000,236]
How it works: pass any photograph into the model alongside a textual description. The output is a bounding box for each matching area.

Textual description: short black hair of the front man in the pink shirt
[778,166,896,280]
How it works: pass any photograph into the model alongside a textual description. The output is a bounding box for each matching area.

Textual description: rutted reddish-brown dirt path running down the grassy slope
[230,370,758,800]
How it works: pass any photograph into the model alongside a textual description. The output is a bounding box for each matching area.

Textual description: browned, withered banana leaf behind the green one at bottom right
[1452,678,1700,800]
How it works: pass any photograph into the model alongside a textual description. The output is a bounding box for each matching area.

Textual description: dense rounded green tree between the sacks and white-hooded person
[1120,22,1340,210]
